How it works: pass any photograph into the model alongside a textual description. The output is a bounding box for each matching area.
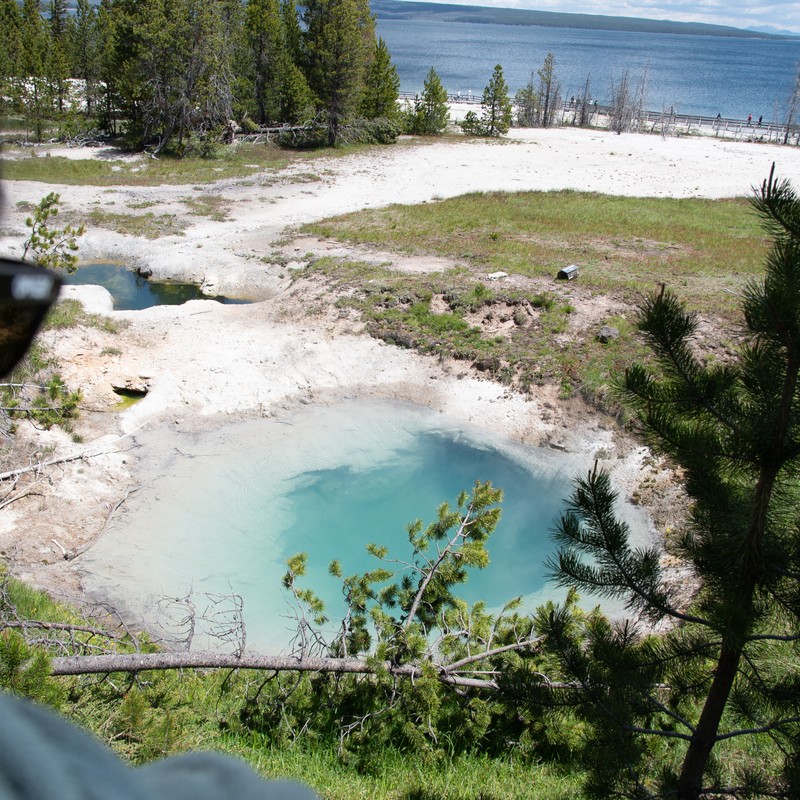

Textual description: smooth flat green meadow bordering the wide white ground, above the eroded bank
[303,191,769,314]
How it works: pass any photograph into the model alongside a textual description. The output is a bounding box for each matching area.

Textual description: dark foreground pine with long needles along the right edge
[539,168,800,800]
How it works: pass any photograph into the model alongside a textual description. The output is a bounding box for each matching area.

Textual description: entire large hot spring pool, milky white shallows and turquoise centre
[75,401,648,652]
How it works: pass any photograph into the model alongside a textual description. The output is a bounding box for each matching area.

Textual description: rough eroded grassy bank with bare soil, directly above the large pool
[306,258,620,395]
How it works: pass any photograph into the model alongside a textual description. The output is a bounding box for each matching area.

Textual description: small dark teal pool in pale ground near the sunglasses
[65,263,249,311]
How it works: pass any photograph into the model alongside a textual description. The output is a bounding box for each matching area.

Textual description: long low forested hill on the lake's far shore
[371,0,784,39]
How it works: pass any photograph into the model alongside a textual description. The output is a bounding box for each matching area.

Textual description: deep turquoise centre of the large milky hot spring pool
[285,430,569,606]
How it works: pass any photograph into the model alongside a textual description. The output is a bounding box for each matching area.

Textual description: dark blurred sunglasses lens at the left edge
[0,259,61,376]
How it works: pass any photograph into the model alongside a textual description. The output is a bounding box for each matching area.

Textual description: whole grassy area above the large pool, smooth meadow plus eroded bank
[296,191,769,412]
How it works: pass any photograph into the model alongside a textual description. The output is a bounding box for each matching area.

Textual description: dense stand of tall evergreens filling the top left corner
[0,0,398,154]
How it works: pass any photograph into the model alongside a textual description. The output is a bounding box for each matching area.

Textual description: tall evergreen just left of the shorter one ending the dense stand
[303,0,375,146]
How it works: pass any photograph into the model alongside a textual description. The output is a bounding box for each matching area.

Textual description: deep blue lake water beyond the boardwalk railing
[378,19,800,122]
